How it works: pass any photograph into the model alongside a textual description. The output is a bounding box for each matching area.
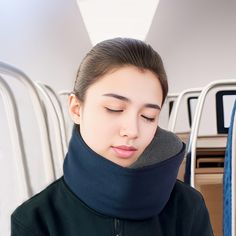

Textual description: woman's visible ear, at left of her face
[69,94,82,124]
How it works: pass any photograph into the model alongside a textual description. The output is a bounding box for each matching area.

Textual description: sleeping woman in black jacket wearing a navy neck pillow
[11,38,213,236]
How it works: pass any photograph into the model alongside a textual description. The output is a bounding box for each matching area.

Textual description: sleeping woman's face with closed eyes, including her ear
[69,66,162,167]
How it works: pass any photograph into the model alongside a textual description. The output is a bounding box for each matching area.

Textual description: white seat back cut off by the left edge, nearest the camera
[0,76,31,234]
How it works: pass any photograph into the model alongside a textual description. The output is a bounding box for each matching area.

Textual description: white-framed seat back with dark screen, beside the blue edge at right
[185,80,236,236]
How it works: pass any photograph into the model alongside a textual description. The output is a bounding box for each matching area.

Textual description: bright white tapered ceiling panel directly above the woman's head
[77,0,159,45]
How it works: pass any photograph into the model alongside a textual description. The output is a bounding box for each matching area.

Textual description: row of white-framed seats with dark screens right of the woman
[160,80,236,236]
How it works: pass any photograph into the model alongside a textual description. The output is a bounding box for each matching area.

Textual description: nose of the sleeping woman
[120,114,139,139]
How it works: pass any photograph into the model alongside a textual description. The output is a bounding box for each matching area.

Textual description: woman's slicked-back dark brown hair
[74,38,168,104]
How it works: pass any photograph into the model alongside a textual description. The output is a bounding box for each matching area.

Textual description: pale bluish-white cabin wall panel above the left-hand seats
[0,0,92,91]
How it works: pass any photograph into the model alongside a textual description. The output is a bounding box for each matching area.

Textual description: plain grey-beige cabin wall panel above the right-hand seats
[146,0,236,93]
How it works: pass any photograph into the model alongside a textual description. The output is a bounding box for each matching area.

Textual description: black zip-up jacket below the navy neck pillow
[11,177,213,236]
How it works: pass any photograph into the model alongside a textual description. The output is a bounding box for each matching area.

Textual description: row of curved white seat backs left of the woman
[0,62,72,235]
